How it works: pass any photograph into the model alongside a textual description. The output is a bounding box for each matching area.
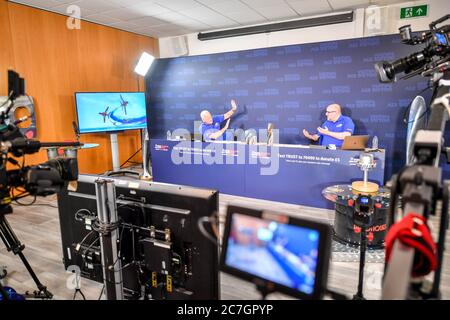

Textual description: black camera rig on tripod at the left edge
[0,71,80,300]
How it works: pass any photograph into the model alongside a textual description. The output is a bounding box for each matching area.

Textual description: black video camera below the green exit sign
[375,14,450,83]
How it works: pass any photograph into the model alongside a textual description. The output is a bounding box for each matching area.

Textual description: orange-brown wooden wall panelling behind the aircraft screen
[0,0,157,173]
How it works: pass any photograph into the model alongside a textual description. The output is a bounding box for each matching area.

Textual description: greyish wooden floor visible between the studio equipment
[0,195,450,299]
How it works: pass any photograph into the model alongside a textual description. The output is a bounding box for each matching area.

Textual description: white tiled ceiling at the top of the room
[10,0,405,38]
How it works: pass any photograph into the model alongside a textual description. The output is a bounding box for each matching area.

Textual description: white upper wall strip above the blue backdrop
[159,0,450,58]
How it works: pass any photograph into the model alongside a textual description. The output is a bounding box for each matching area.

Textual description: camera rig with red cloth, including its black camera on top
[375,15,450,299]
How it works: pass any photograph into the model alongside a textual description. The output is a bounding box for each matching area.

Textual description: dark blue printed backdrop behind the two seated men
[146,35,448,178]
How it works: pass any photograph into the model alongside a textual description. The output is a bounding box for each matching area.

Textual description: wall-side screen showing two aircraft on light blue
[75,92,147,133]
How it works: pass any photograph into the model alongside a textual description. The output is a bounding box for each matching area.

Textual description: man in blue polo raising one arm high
[199,100,237,141]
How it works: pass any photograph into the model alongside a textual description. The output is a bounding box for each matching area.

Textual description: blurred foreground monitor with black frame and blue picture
[220,206,331,299]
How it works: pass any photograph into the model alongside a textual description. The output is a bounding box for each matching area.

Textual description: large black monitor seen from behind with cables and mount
[58,174,219,300]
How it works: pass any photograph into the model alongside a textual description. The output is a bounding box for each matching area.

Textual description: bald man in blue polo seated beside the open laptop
[303,104,355,148]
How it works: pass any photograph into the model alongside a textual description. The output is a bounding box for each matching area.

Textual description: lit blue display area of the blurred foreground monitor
[225,214,320,294]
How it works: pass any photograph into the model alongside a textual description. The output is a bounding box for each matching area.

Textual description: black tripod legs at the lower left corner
[0,205,53,300]
